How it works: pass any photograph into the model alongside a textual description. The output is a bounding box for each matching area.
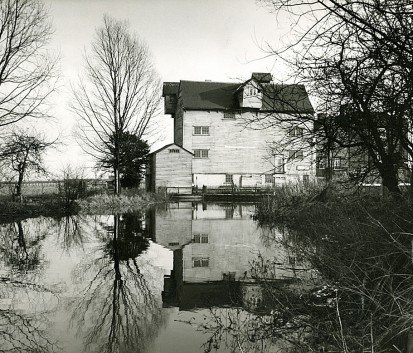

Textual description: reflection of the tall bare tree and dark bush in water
[72,215,166,353]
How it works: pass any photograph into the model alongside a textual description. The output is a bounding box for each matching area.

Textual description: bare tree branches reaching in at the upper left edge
[0,0,56,127]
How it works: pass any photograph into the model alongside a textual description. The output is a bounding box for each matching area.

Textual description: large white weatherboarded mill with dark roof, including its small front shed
[151,73,315,192]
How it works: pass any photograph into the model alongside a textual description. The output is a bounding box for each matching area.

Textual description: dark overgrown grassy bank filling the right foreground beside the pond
[255,185,413,352]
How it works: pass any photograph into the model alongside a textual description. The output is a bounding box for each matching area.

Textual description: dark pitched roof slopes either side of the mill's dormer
[175,81,314,113]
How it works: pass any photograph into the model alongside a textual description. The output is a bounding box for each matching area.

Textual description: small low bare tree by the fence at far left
[0,131,56,202]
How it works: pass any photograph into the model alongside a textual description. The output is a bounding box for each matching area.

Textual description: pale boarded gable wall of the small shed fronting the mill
[155,145,192,190]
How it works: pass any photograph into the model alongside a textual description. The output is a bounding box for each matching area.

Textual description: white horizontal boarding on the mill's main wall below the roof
[183,111,315,176]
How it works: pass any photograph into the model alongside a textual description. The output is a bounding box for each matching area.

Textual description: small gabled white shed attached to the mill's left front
[146,143,193,194]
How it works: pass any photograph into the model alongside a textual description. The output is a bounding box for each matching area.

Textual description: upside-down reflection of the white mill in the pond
[147,203,311,311]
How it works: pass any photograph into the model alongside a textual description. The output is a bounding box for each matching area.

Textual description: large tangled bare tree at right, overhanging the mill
[256,0,413,193]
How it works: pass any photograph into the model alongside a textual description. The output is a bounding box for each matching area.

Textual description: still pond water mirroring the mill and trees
[0,203,314,353]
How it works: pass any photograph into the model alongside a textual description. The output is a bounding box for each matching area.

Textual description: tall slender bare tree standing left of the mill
[72,16,160,194]
